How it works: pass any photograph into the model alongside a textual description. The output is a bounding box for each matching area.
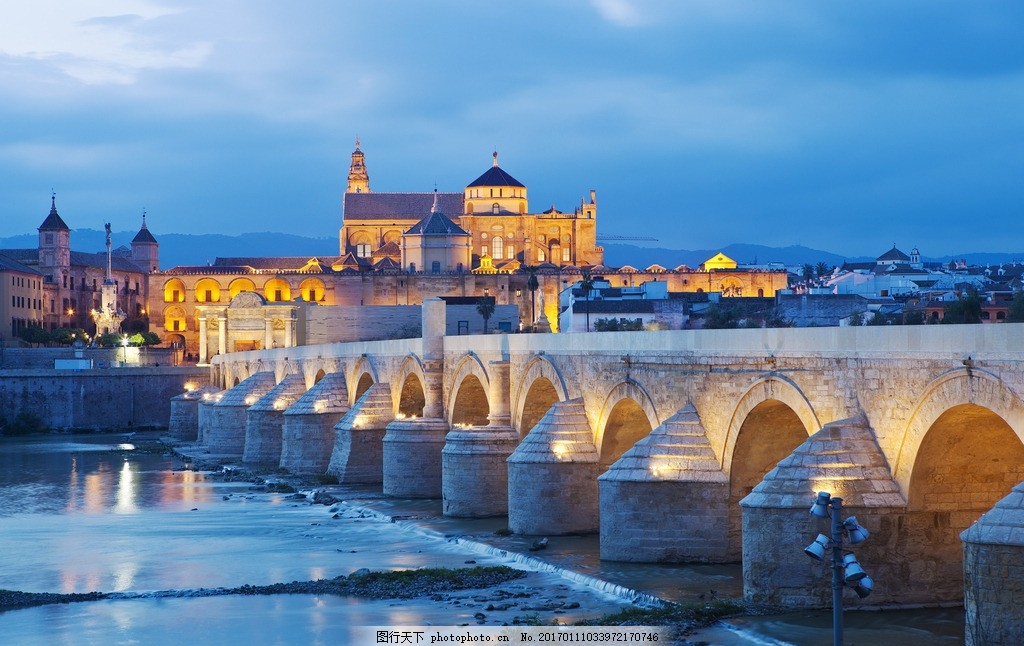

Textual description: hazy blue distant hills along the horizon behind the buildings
[0,229,1024,269]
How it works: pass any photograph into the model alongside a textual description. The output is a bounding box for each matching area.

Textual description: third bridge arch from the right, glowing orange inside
[594,379,662,472]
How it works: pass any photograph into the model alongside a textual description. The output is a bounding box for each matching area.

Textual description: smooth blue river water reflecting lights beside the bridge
[0,435,963,646]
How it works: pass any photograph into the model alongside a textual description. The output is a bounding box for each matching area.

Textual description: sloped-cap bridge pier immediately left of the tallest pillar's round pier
[328,382,394,484]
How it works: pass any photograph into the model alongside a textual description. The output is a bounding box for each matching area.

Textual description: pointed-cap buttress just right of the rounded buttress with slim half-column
[508,399,600,534]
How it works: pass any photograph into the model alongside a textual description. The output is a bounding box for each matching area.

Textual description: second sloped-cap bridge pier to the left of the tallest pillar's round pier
[280,372,349,475]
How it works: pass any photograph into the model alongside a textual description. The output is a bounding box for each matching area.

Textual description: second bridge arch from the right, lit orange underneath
[722,375,821,560]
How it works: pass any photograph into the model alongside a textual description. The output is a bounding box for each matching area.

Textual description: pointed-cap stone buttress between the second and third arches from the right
[598,403,729,563]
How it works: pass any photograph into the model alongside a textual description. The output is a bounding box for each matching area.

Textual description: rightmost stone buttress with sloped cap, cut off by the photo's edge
[961,483,1024,646]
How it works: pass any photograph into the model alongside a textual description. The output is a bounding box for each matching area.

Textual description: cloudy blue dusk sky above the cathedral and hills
[0,0,1024,257]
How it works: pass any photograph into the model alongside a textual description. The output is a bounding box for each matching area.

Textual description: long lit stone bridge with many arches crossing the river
[177,299,1024,634]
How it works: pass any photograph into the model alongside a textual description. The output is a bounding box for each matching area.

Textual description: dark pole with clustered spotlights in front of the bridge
[804,491,874,646]
